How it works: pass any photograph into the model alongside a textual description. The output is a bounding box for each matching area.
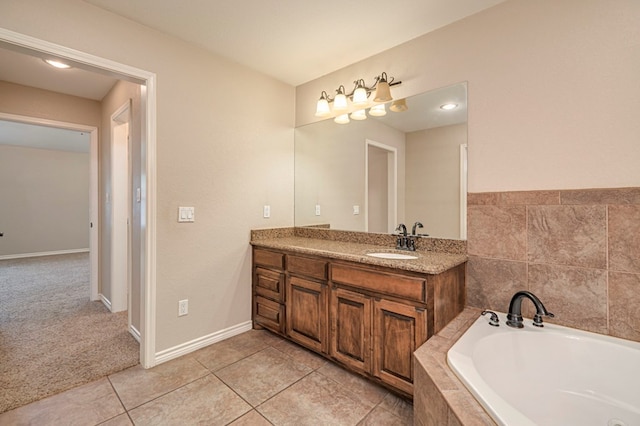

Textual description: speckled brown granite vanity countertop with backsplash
[251,228,467,274]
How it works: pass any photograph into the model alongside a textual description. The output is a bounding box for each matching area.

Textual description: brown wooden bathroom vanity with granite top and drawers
[252,228,466,397]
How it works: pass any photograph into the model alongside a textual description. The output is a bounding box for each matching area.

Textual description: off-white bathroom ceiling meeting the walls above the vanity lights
[85,0,504,86]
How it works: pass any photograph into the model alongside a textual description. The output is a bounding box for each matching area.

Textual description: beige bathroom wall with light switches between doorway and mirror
[0,0,294,351]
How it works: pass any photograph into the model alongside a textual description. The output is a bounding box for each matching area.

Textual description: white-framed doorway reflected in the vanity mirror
[365,140,398,233]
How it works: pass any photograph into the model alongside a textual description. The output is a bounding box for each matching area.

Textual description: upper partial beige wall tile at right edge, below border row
[609,204,640,273]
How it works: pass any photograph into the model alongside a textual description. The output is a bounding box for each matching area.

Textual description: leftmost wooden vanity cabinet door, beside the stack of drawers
[286,276,329,353]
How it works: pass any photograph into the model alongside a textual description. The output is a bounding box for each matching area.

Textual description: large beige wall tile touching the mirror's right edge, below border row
[467,206,526,260]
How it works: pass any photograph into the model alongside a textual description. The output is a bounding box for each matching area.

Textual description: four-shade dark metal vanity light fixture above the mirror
[315,72,402,124]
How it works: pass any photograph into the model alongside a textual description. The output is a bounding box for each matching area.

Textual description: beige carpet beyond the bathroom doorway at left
[0,253,139,413]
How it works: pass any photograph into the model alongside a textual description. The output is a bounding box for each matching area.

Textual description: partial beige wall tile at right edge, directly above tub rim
[609,272,640,341]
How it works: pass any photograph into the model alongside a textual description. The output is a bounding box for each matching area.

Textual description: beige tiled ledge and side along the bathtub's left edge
[413,307,496,426]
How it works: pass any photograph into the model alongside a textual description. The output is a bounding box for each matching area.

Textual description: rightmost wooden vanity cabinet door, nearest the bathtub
[373,299,427,395]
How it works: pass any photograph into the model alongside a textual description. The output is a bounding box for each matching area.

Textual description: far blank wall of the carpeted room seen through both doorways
[0,145,89,256]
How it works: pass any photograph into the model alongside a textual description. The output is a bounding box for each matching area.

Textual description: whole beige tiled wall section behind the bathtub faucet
[467,188,640,341]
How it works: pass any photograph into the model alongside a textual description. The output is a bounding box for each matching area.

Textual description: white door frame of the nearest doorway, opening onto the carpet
[0,28,157,368]
